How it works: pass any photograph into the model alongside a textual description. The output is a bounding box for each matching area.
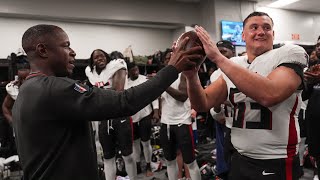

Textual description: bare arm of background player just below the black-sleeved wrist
[166,74,188,102]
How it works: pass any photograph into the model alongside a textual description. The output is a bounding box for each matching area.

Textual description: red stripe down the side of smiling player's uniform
[286,96,298,180]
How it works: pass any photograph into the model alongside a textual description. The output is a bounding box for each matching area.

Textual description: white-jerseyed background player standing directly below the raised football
[160,50,201,180]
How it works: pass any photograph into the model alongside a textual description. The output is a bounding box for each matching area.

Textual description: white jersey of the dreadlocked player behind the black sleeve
[85,59,127,89]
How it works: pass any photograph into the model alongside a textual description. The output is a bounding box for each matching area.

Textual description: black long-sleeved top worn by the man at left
[13,66,178,180]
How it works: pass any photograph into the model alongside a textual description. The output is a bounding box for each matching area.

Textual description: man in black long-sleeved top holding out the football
[13,25,201,180]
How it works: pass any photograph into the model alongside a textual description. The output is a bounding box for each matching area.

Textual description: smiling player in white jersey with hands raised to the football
[184,12,307,180]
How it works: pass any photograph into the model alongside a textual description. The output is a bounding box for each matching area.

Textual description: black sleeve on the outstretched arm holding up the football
[48,66,178,121]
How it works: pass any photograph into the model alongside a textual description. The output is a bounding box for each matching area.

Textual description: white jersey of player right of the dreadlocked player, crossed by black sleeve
[126,75,159,123]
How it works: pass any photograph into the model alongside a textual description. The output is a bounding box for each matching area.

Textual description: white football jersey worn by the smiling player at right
[223,45,308,159]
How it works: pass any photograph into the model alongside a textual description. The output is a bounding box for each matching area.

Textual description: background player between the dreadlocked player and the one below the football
[126,62,160,177]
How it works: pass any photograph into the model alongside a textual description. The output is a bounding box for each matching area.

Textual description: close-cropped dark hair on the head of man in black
[22,24,61,54]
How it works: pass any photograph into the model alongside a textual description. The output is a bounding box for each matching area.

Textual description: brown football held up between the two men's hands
[177,31,206,56]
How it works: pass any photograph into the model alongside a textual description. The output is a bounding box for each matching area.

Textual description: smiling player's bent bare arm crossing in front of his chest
[217,60,302,107]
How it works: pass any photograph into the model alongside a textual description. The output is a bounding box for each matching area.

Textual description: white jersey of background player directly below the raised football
[161,73,191,125]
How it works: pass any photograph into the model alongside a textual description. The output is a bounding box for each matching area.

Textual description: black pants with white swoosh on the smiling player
[229,152,300,180]
